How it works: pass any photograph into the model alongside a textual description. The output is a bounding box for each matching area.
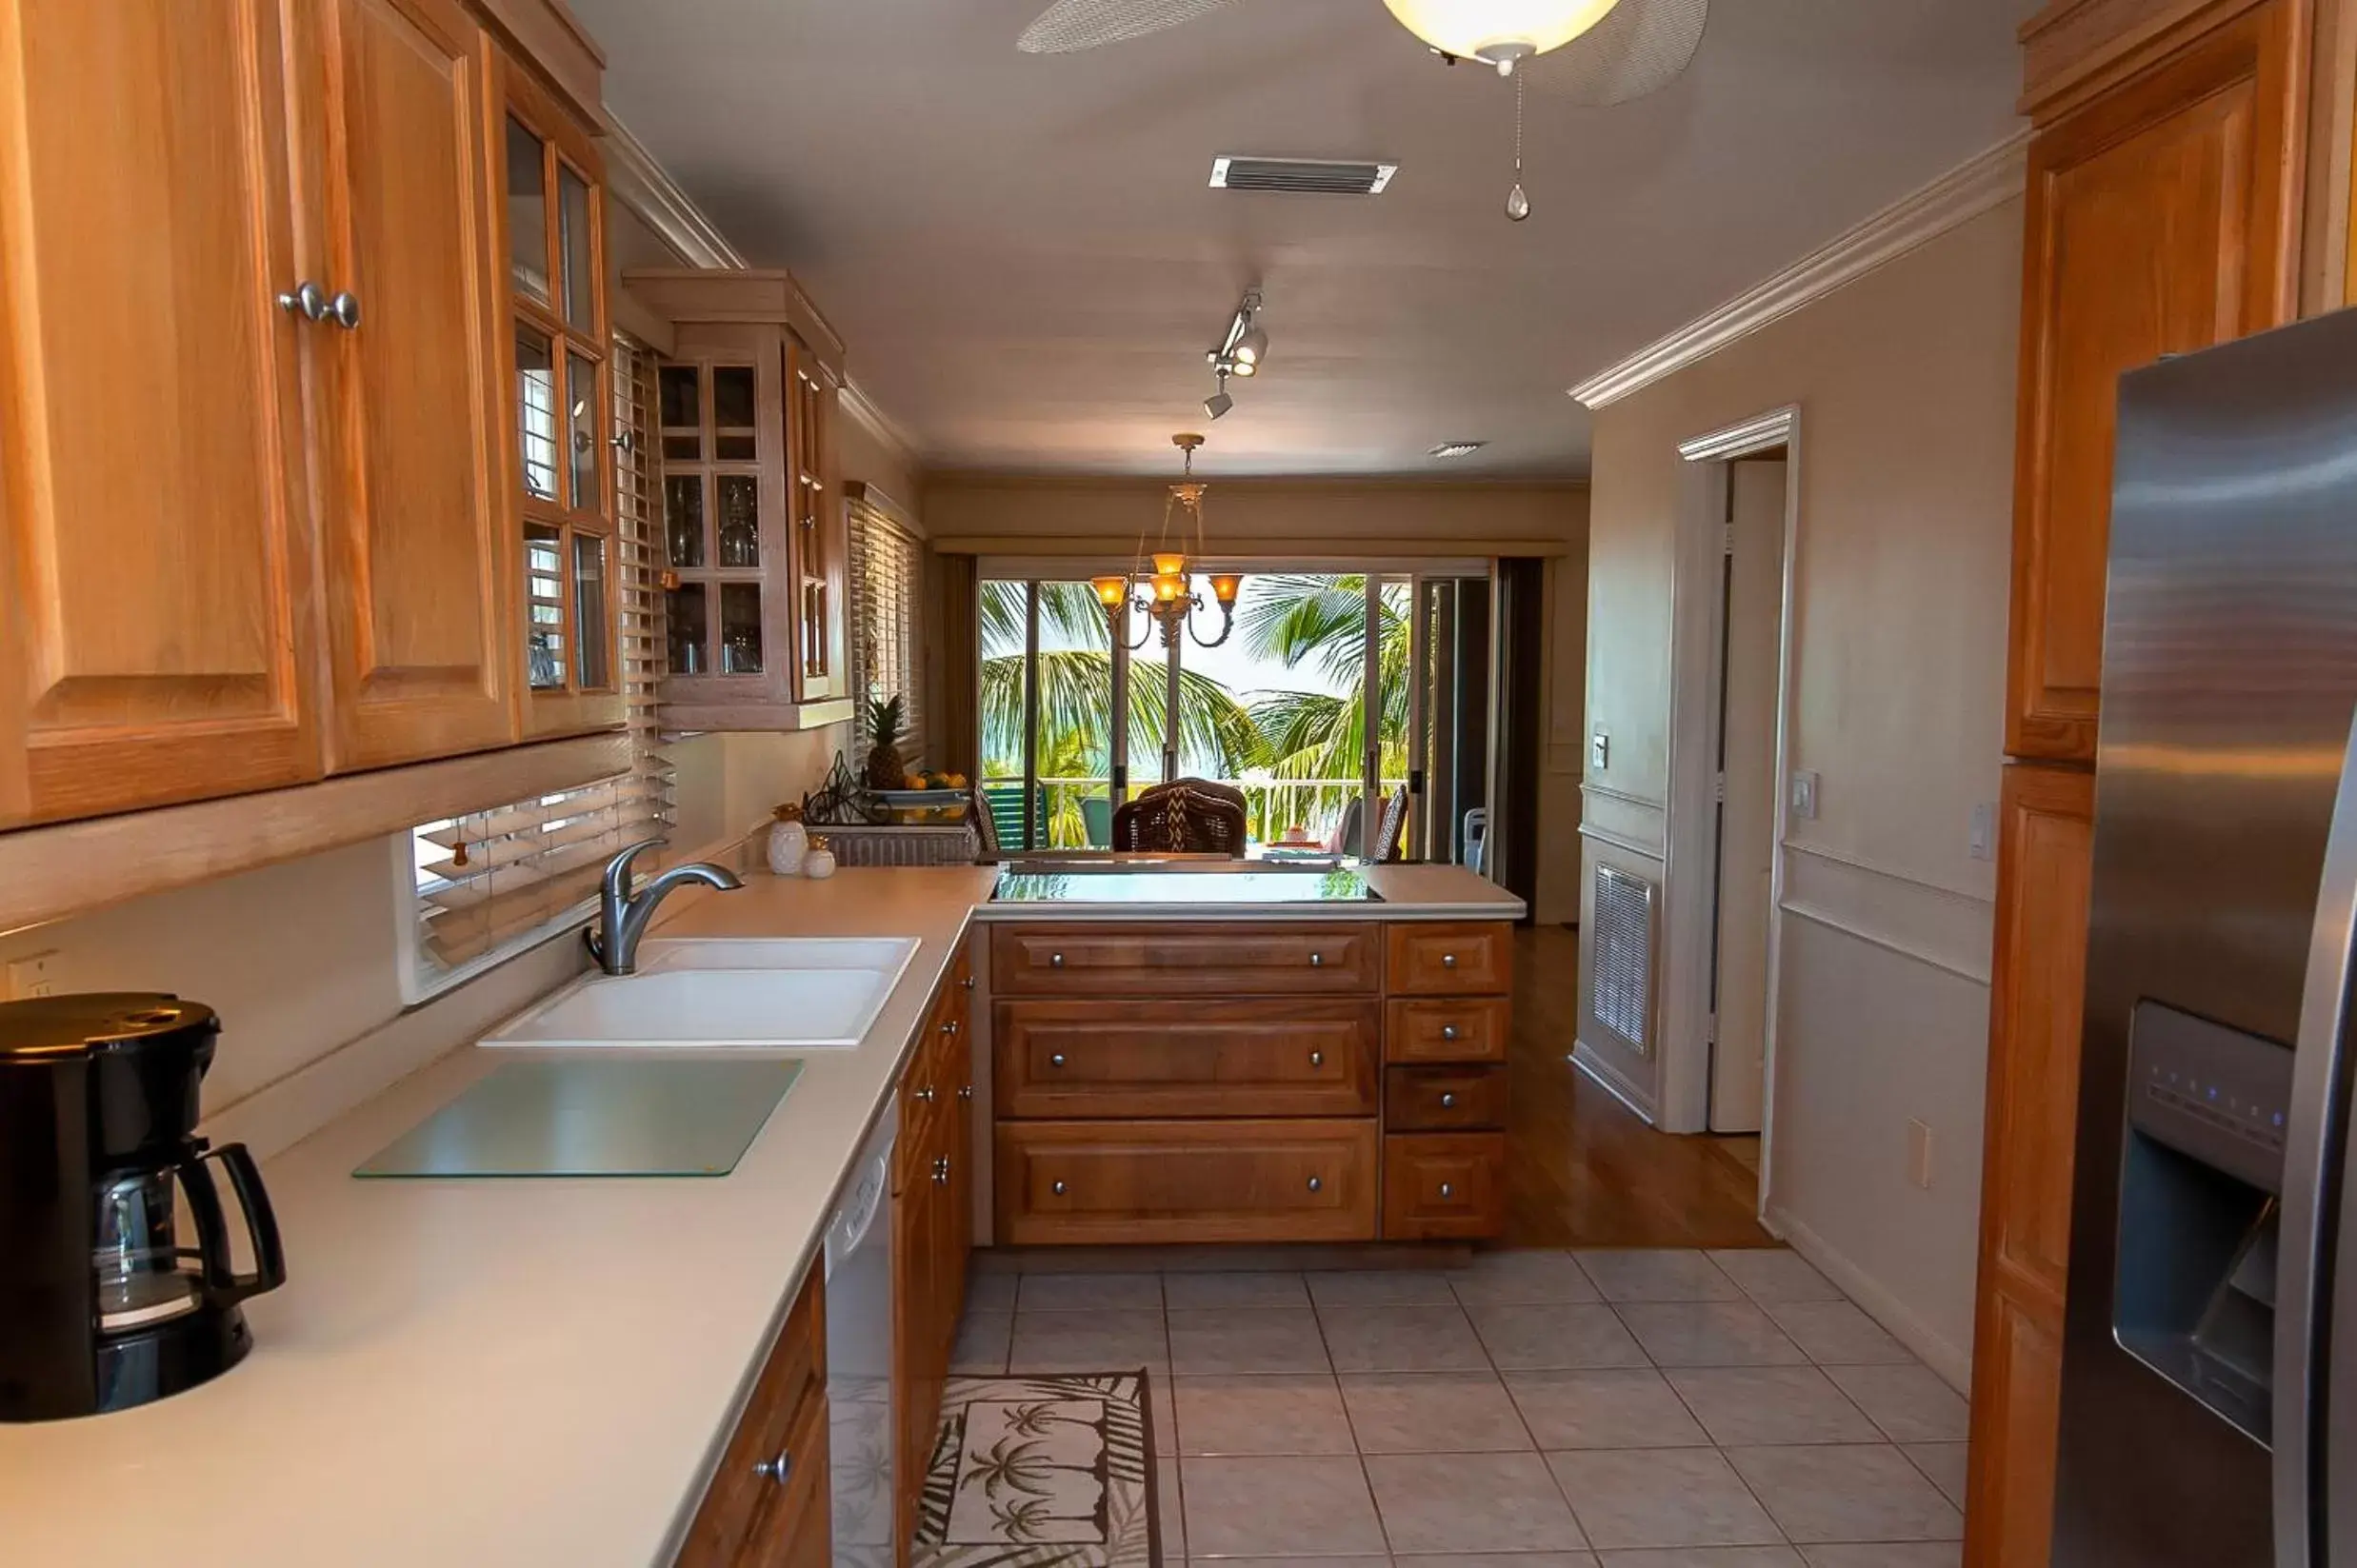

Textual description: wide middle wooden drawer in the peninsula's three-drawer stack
[992,998,1384,1120]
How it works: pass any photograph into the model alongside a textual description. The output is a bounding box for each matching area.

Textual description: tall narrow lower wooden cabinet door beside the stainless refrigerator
[1966,764,2095,1568]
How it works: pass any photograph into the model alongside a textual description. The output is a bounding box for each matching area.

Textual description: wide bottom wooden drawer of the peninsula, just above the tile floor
[997,1120,1379,1247]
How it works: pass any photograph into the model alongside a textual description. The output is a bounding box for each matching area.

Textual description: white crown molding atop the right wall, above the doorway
[1572,129,2029,407]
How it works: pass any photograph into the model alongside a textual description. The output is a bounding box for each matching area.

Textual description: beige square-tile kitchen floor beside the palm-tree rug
[957,1252,1966,1568]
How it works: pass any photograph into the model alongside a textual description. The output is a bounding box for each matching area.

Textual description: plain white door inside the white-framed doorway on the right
[1711,457,1785,1132]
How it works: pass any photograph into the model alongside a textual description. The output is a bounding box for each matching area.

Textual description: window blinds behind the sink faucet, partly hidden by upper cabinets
[403,335,671,1002]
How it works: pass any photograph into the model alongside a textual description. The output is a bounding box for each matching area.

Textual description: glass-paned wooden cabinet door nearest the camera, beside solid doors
[500,64,622,736]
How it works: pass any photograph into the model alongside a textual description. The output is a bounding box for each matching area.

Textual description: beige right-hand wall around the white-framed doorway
[1582,201,2023,1375]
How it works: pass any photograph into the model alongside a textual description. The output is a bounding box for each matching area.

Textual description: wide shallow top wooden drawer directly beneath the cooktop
[990,922,1384,998]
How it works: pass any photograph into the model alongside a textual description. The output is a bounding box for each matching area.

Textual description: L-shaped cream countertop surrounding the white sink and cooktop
[0,865,1520,1568]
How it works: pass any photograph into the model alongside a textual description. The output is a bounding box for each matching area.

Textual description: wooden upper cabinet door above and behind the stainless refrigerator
[2006,0,2307,762]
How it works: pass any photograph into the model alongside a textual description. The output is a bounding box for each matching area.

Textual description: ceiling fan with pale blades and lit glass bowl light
[1016,0,1711,106]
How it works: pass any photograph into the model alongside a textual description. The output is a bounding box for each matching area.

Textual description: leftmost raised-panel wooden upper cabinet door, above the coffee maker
[0,0,321,825]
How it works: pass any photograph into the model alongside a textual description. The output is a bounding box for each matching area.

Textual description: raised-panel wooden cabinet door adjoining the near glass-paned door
[307,0,516,768]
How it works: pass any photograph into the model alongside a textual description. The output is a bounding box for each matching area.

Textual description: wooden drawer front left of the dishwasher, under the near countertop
[679,1266,828,1568]
